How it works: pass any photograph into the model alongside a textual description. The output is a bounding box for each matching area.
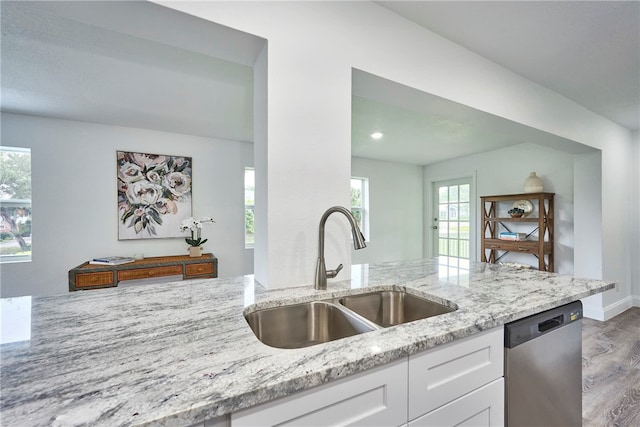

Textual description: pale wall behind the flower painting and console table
[1,113,253,297]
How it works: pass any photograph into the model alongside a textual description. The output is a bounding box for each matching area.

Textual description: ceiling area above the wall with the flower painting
[1,1,265,142]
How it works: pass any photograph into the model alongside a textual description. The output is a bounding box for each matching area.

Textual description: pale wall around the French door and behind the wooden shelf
[425,143,574,274]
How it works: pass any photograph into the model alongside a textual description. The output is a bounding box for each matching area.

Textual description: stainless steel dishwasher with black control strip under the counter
[504,301,582,427]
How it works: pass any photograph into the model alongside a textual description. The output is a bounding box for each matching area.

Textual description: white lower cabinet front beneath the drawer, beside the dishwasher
[409,378,504,427]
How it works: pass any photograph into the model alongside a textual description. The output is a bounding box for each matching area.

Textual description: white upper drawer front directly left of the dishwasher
[409,327,504,420]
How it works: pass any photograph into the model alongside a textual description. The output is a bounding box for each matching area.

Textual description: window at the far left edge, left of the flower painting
[0,147,31,262]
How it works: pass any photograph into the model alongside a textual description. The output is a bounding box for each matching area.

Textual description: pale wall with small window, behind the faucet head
[350,157,423,268]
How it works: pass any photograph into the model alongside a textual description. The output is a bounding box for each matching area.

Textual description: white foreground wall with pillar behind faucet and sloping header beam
[120,1,632,312]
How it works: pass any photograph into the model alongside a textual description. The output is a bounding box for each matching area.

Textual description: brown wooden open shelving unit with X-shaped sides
[480,193,555,271]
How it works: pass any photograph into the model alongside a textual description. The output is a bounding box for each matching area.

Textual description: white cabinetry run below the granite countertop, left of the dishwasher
[225,327,504,427]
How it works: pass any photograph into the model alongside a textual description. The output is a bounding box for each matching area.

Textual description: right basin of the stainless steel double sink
[339,291,456,328]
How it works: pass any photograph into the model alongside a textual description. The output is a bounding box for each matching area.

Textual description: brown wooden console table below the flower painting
[69,254,218,291]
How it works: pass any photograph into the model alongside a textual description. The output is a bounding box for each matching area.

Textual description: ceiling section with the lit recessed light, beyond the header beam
[351,70,591,165]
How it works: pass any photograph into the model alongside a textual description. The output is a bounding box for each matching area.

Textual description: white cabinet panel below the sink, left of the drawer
[231,358,408,427]
